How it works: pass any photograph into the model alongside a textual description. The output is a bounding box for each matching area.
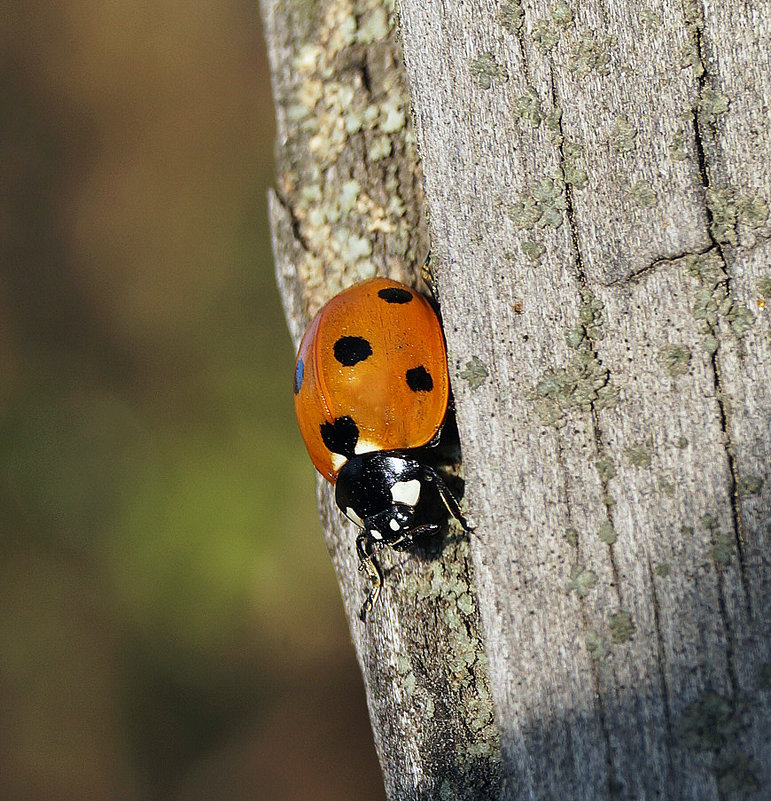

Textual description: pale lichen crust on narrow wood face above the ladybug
[278,0,426,315]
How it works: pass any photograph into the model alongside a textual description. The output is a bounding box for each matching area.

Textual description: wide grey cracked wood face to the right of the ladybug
[401,1,771,799]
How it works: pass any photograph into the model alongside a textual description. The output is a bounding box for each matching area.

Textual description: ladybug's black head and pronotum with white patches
[335,451,438,547]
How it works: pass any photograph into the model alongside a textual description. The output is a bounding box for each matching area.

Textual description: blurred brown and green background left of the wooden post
[0,0,383,801]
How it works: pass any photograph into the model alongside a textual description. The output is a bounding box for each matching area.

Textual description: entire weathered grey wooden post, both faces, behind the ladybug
[264,0,771,801]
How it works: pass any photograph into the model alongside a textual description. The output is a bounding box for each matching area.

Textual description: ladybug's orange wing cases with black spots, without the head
[295,278,449,483]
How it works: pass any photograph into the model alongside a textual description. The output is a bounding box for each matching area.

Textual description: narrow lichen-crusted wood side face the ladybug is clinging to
[263,0,502,799]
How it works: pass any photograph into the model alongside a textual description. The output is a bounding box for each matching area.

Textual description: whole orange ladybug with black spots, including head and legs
[294,278,470,621]
